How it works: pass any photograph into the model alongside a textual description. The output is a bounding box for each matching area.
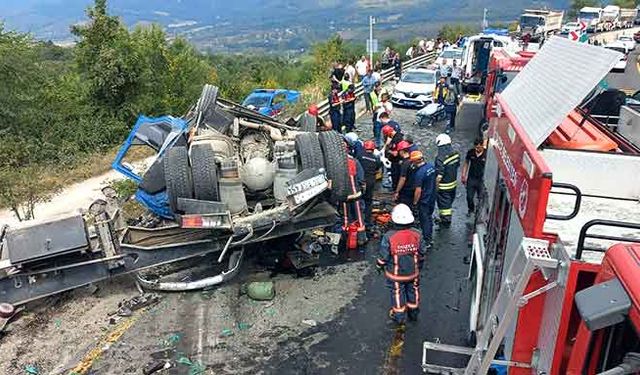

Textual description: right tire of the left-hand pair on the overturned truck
[191,144,220,201]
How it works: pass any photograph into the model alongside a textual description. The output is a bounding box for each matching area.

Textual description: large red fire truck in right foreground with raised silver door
[422,38,640,375]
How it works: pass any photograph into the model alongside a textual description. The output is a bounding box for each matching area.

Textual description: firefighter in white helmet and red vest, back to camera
[376,204,426,324]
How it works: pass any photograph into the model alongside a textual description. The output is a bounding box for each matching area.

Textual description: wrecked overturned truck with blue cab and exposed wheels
[0,85,349,315]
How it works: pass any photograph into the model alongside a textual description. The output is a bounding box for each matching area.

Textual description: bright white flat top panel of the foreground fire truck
[540,149,640,200]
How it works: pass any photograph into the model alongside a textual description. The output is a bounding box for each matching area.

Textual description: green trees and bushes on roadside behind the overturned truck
[0,0,468,220]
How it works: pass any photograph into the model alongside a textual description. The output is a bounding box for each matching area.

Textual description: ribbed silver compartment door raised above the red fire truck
[502,37,622,147]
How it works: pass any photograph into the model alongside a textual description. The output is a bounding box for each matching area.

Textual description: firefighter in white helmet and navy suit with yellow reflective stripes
[436,134,460,227]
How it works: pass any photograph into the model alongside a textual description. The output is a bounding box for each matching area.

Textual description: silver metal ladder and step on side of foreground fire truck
[422,238,559,375]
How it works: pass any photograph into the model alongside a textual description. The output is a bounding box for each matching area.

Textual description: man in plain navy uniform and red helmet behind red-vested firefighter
[409,151,436,248]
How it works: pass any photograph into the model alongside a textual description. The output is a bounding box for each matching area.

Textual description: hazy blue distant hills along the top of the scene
[0,0,569,51]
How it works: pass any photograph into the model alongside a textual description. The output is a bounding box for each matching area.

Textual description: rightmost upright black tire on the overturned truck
[318,130,350,201]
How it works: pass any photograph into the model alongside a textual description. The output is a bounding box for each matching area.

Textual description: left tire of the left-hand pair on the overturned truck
[163,146,193,213]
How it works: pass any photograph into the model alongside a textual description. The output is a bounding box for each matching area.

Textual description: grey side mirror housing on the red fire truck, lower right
[575,278,631,331]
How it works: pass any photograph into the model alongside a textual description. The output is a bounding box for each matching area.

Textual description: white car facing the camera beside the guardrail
[391,68,439,108]
